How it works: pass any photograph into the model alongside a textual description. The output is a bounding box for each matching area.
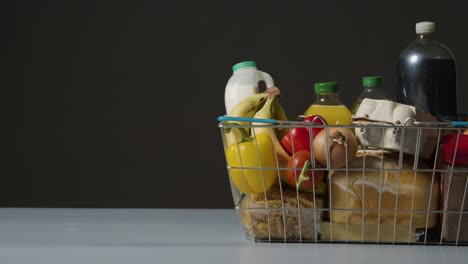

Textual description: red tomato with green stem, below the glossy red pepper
[286,150,325,194]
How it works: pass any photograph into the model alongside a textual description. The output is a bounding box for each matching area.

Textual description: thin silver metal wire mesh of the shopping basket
[218,121,468,246]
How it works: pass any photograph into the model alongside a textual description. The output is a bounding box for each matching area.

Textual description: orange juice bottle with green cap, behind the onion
[305,82,352,125]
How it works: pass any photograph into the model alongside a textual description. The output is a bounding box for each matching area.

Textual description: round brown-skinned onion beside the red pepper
[314,127,358,169]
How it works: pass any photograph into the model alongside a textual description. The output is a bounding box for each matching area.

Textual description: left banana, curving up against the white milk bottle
[226,91,270,146]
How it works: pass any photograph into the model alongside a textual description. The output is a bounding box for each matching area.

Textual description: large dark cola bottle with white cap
[396,22,457,121]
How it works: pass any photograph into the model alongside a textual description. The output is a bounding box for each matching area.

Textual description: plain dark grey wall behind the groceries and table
[4,0,468,208]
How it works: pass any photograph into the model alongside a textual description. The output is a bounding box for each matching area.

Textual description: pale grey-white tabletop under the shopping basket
[0,208,468,264]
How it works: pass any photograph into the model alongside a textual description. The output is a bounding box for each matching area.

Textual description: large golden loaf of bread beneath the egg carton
[328,155,440,228]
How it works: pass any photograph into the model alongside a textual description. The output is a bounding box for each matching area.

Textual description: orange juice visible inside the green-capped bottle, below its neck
[305,104,352,126]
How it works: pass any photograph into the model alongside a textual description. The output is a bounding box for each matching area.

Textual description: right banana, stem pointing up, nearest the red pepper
[251,88,290,163]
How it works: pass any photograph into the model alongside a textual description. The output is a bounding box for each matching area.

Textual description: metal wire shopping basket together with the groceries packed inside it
[218,116,468,246]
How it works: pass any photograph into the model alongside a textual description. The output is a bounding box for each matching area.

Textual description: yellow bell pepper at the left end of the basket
[226,128,278,193]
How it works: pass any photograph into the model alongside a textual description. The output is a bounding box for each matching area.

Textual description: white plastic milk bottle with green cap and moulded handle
[224,61,274,115]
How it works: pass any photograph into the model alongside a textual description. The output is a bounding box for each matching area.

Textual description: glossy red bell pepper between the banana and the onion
[281,115,327,155]
